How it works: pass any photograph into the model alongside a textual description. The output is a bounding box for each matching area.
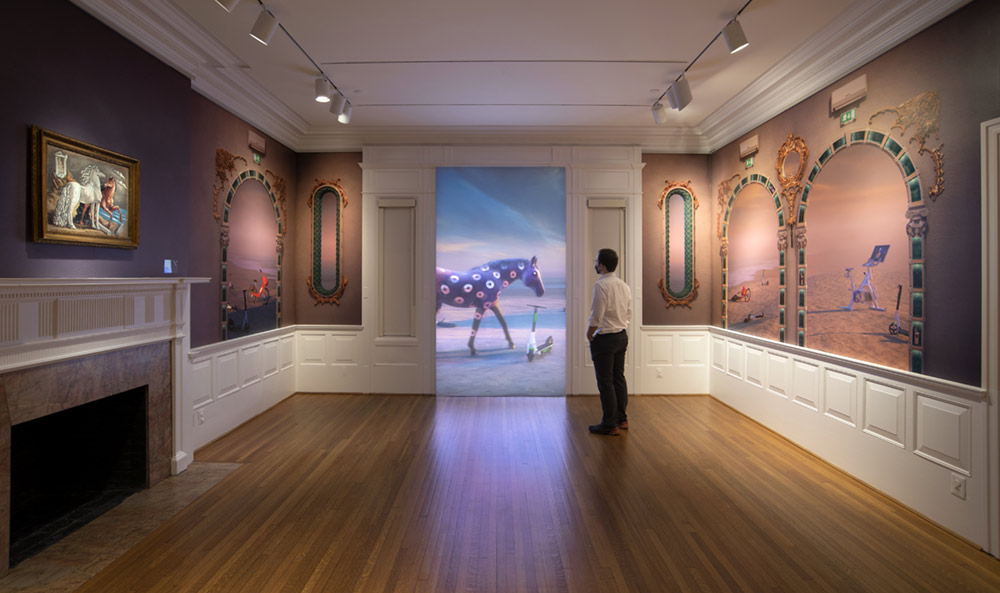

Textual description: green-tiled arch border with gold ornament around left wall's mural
[212,148,287,340]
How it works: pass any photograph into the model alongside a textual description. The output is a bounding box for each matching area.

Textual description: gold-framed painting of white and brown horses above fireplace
[31,126,139,249]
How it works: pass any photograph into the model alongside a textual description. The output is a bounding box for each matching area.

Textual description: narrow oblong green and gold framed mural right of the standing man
[656,180,698,307]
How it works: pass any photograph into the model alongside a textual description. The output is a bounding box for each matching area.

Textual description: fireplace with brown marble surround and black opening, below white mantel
[0,342,172,574]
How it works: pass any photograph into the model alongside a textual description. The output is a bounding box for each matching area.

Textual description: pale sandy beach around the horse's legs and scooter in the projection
[435,286,566,396]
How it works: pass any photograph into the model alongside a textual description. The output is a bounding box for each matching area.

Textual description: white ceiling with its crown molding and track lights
[72,0,969,152]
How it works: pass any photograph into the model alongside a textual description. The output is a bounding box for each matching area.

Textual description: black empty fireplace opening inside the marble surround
[10,387,149,567]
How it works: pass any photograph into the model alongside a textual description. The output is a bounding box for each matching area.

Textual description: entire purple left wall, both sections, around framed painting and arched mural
[0,0,297,346]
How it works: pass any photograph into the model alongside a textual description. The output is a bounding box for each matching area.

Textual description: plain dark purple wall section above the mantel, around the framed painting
[0,0,194,277]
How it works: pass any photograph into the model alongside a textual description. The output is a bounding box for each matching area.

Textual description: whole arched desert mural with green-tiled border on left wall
[212,148,286,340]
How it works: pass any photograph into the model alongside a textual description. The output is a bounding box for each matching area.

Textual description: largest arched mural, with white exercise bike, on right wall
[796,119,944,373]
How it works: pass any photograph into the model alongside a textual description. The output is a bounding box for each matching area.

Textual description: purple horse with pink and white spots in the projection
[435,257,545,356]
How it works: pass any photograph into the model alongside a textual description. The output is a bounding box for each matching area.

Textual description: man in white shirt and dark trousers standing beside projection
[587,248,632,436]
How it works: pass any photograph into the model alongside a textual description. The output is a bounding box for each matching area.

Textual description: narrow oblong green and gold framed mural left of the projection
[306,179,347,305]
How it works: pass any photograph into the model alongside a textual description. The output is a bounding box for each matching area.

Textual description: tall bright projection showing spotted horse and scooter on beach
[435,167,566,396]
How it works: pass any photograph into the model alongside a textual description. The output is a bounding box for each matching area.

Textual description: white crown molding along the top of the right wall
[701,0,971,152]
